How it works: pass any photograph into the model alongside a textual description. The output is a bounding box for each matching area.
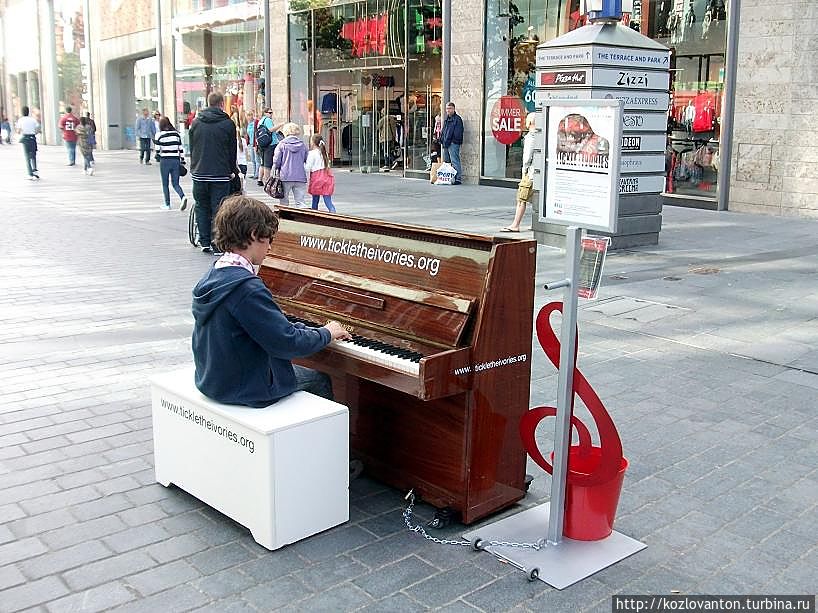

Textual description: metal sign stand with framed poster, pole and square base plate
[463,97,645,590]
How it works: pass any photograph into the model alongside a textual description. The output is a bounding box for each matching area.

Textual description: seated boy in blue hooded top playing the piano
[193,196,351,407]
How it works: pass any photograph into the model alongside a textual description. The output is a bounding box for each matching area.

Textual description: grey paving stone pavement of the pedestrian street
[0,146,818,613]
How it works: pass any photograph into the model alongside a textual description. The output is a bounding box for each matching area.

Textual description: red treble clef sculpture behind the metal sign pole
[520,302,627,516]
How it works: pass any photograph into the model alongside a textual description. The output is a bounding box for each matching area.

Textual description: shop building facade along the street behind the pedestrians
[0,0,818,217]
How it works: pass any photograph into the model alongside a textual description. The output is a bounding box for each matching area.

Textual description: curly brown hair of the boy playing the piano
[213,196,278,251]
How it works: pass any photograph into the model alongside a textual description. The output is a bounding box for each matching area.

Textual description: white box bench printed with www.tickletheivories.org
[151,368,349,549]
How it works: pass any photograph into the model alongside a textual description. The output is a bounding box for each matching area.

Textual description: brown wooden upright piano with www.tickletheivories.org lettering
[259,207,536,524]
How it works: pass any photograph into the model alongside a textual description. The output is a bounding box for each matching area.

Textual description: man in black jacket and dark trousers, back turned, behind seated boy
[190,92,238,253]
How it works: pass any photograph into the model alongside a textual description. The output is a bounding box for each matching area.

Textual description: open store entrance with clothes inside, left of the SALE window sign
[315,67,407,174]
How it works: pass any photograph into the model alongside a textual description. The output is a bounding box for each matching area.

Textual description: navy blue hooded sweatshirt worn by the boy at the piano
[193,266,332,407]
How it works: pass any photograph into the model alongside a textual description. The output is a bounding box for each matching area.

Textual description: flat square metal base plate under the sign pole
[463,502,647,590]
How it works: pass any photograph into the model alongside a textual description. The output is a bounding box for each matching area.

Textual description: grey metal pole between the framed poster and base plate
[548,226,582,545]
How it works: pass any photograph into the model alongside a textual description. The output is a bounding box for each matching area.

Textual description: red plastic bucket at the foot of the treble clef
[552,446,628,541]
